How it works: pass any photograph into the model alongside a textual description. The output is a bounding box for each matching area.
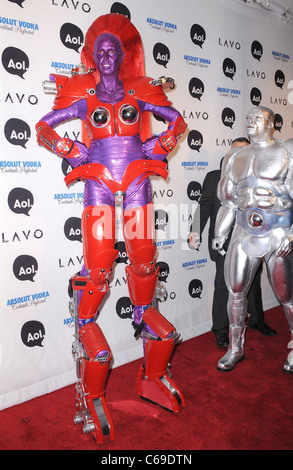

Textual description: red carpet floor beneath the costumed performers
[0,307,293,454]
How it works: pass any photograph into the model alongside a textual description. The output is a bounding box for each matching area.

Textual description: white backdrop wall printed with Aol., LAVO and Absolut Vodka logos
[0,0,293,409]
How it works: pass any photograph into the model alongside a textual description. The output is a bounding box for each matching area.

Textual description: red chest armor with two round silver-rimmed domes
[85,94,141,140]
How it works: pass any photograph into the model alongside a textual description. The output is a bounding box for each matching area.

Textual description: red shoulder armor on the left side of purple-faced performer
[52,73,96,109]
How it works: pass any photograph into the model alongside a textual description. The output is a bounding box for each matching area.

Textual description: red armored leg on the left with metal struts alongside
[71,207,118,444]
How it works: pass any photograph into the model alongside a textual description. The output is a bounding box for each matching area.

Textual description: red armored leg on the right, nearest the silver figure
[124,206,185,413]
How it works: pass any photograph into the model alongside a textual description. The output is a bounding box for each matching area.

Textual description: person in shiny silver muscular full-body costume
[213,106,293,373]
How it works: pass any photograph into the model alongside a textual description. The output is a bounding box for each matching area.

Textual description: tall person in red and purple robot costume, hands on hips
[36,13,186,443]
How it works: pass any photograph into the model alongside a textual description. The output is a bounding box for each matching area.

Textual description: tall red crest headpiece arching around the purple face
[81,13,145,81]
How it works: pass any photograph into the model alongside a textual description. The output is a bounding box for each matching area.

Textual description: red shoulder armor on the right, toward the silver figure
[124,77,172,106]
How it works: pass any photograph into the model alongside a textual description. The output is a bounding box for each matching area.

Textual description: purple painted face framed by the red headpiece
[93,33,124,75]
